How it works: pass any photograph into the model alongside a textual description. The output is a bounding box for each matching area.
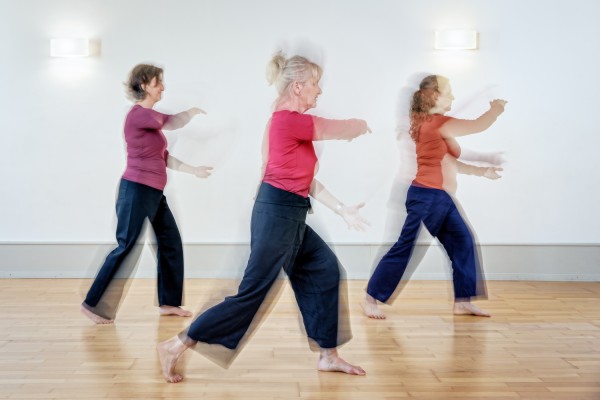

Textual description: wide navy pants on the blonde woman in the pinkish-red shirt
[186,183,341,349]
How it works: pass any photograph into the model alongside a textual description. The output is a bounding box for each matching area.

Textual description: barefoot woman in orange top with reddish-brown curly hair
[363,75,506,318]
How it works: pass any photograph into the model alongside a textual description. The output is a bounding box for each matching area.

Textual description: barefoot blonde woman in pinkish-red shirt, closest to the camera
[158,54,369,383]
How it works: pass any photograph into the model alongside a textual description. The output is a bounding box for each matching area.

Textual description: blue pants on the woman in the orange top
[367,185,484,302]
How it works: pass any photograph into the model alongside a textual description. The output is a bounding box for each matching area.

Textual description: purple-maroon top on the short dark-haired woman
[123,104,171,190]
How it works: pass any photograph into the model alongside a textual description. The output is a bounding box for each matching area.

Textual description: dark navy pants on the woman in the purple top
[84,179,183,308]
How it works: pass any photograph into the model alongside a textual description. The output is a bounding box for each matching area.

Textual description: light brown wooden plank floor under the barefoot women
[0,279,600,400]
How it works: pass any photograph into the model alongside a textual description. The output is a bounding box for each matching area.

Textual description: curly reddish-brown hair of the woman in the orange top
[409,75,448,142]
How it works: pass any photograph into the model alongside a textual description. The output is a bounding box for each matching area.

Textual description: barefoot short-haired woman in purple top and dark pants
[81,64,212,324]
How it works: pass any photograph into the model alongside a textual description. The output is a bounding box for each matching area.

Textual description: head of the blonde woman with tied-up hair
[267,52,323,108]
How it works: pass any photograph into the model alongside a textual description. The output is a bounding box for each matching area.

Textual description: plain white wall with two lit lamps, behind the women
[0,0,600,278]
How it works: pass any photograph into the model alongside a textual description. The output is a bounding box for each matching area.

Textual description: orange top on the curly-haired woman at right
[413,114,451,190]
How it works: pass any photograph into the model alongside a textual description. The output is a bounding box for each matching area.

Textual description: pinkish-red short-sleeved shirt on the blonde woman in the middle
[263,110,317,197]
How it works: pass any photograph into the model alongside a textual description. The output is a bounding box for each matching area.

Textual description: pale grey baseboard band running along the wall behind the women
[0,243,600,281]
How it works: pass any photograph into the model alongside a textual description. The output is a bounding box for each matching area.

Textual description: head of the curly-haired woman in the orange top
[410,75,454,140]
